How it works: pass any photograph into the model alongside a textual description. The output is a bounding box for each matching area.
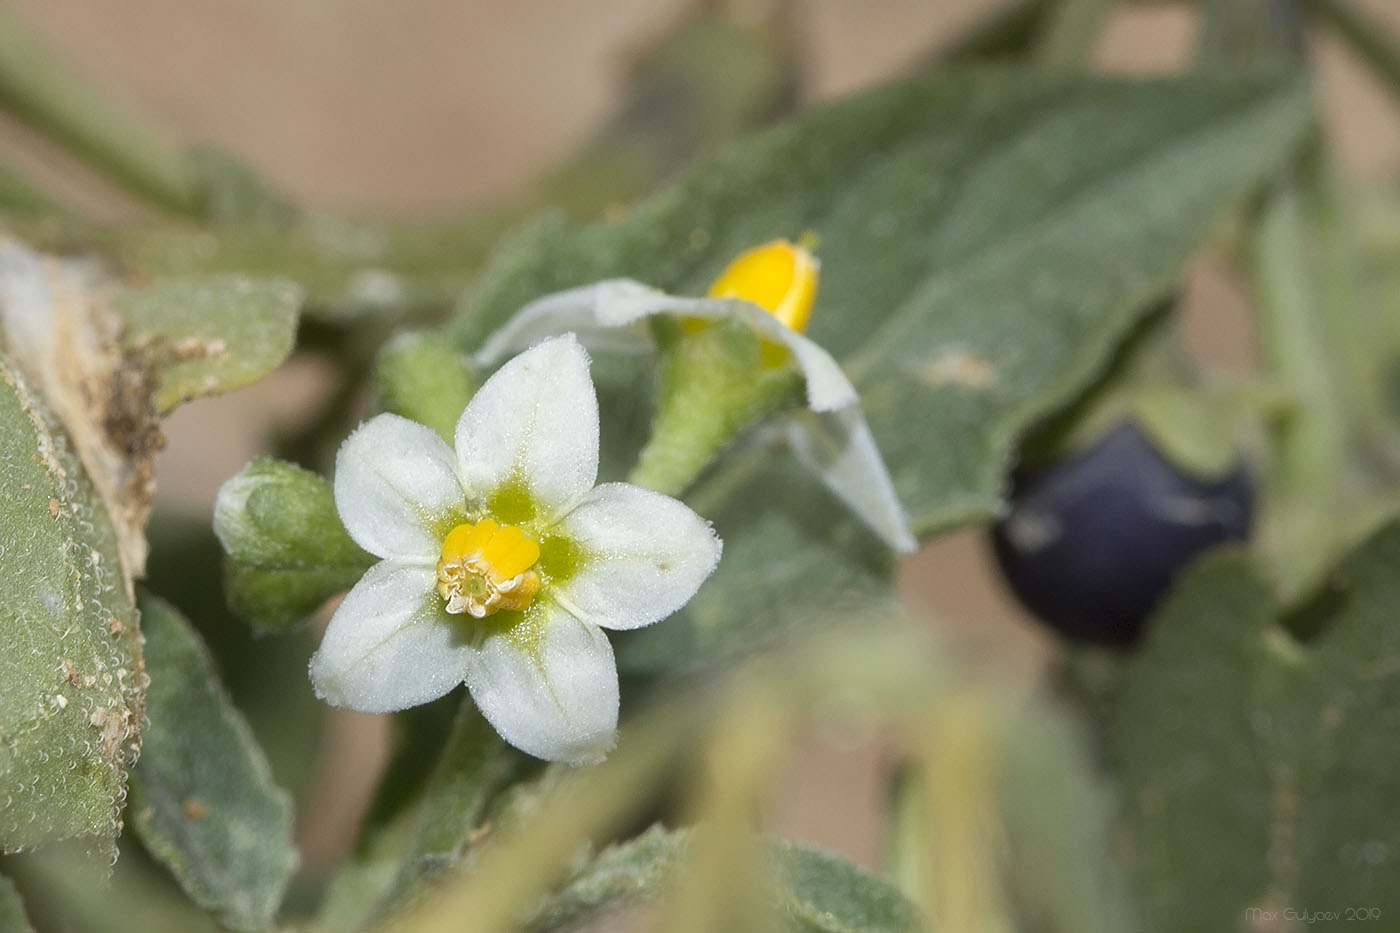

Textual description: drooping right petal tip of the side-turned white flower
[784,405,918,553]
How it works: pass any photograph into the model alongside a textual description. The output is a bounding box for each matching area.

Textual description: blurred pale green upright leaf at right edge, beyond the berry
[1250,175,1400,601]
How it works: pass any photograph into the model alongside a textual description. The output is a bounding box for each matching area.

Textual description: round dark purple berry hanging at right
[993,423,1254,646]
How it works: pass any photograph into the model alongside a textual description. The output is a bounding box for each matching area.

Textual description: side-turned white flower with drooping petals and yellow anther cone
[476,240,917,552]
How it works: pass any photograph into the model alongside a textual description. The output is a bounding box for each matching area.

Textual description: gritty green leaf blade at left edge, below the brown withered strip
[0,357,146,855]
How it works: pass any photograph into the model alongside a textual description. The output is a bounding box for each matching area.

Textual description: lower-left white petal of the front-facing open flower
[311,560,469,713]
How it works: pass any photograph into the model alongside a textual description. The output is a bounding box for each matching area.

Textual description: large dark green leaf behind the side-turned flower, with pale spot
[451,73,1309,532]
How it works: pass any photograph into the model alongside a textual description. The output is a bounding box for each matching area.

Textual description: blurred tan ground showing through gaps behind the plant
[0,0,1400,866]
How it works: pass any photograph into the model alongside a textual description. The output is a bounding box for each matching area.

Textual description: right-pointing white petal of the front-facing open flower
[550,483,720,629]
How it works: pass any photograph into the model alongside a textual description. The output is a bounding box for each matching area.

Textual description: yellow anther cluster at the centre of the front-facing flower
[437,518,539,619]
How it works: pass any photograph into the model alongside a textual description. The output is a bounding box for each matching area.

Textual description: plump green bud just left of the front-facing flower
[214,457,374,630]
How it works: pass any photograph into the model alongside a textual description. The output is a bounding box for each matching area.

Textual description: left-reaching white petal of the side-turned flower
[475,279,657,366]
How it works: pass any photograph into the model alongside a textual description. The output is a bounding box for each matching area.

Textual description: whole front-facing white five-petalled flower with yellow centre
[311,335,720,763]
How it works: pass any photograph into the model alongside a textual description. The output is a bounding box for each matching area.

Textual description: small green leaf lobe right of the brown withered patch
[118,275,302,415]
